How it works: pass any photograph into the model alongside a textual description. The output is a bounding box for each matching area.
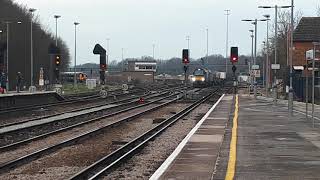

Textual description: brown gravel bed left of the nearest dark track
[0,104,189,180]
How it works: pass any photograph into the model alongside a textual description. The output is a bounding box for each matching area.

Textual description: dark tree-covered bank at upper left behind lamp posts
[0,0,70,88]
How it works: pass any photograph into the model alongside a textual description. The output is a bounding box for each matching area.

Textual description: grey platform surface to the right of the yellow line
[213,95,320,180]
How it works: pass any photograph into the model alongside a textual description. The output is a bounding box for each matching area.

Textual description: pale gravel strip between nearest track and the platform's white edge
[104,104,211,180]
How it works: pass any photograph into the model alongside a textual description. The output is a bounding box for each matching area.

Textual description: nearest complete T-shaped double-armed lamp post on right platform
[258,5,291,105]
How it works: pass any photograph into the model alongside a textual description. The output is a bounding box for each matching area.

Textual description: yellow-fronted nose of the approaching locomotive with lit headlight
[191,68,213,87]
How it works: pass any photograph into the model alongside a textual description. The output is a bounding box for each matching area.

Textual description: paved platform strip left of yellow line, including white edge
[150,95,233,180]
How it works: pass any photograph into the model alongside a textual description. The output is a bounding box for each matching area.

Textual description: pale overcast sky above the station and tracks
[15,0,320,64]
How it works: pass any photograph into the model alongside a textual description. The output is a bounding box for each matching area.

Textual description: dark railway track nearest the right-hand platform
[70,89,219,180]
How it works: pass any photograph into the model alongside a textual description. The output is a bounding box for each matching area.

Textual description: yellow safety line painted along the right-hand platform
[225,95,239,180]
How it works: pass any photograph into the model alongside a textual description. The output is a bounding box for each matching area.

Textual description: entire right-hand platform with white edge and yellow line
[151,94,320,180]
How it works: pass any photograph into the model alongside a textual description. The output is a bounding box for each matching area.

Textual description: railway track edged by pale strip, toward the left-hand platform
[0,87,186,150]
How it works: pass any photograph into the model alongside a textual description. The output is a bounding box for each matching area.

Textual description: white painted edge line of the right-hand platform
[150,94,225,180]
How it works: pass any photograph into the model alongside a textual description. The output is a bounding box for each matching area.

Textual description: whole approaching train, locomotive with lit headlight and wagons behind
[191,68,226,87]
